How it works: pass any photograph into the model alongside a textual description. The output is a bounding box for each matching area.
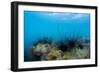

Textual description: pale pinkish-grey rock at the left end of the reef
[33,43,51,60]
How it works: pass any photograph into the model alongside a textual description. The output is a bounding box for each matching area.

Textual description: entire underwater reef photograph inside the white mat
[24,11,90,62]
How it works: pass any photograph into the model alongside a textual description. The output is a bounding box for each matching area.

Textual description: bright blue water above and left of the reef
[24,11,90,61]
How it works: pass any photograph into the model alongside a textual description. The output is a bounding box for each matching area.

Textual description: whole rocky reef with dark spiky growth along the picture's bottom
[31,38,90,61]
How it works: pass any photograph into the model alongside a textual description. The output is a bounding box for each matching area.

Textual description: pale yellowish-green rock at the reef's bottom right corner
[63,48,90,59]
